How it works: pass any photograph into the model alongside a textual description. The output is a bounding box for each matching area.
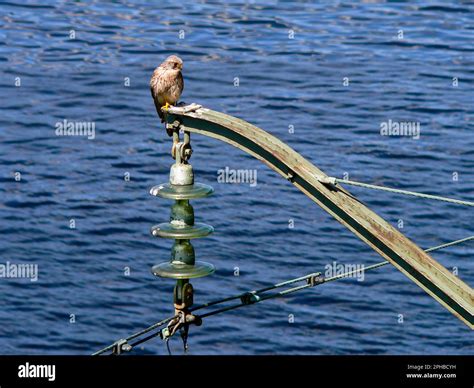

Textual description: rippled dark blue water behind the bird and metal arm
[0,0,474,354]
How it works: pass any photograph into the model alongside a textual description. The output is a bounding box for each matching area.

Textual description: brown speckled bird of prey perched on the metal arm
[150,55,184,122]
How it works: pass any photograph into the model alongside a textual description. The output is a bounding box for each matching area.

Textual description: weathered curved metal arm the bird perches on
[166,104,474,329]
